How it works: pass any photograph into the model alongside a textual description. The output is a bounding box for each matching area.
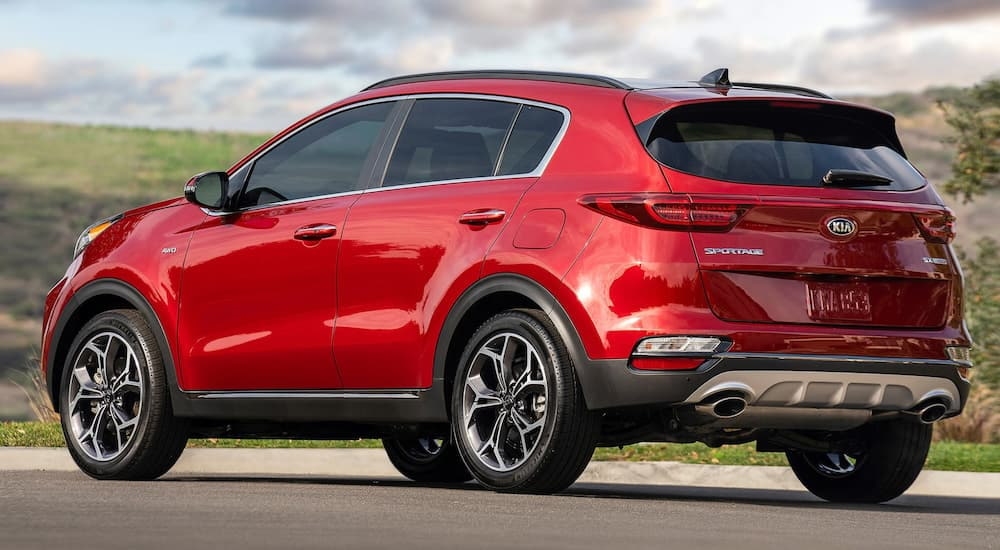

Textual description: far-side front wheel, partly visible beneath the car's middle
[382,437,472,483]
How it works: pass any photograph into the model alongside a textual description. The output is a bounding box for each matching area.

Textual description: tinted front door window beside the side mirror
[240,102,395,207]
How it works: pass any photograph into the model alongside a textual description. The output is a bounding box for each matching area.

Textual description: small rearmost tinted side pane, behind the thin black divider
[499,105,563,176]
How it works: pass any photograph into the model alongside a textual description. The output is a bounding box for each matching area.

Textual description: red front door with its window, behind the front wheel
[178,102,394,391]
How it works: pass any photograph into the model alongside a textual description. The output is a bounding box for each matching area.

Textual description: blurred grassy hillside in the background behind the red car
[0,90,1000,392]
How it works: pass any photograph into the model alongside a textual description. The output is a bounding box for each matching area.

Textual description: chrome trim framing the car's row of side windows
[202,92,572,216]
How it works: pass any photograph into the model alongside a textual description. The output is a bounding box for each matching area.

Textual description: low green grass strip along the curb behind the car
[0,422,1000,472]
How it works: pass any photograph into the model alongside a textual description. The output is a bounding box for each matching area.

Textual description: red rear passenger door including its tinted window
[334,97,566,389]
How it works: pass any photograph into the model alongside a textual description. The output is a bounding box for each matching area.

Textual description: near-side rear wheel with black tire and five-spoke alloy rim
[452,310,600,494]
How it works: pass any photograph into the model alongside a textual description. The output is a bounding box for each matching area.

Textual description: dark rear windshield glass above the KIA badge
[647,101,924,191]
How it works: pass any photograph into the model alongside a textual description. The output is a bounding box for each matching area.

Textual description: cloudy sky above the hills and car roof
[0,0,1000,132]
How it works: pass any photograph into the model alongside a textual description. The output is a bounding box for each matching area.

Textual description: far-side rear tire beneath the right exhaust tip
[786,419,933,503]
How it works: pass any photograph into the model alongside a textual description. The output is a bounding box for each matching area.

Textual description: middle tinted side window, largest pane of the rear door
[382,99,518,187]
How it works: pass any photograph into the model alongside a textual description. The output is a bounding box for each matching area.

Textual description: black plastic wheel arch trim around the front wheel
[45,279,179,412]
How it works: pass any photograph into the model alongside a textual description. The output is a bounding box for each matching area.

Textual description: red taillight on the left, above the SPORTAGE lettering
[579,194,751,232]
